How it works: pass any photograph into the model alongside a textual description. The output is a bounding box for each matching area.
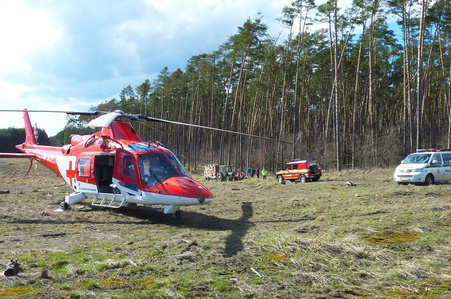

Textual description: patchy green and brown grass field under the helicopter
[0,159,451,298]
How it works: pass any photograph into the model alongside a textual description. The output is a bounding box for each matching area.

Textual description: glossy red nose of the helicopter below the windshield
[162,177,213,203]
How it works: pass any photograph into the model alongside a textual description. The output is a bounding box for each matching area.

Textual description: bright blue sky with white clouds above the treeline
[0,0,340,136]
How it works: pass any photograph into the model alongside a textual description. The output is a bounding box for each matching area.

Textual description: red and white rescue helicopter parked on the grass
[0,109,282,220]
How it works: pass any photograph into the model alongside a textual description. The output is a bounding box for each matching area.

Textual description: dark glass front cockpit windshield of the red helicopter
[138,153,189,186]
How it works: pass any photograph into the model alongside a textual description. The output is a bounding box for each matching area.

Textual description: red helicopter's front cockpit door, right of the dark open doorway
[113,148,140,191]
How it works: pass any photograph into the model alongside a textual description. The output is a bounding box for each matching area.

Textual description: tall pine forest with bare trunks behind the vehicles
[66,0,451,171]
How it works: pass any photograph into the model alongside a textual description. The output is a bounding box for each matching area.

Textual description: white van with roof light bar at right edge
[393,149,451,185]
